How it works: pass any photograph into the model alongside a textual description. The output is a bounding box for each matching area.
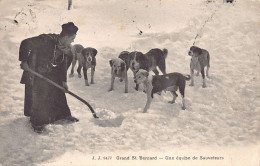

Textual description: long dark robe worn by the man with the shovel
[19,34,72,126]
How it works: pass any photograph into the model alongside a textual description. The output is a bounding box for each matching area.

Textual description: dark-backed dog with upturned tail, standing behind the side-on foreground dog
[130,48,168,90]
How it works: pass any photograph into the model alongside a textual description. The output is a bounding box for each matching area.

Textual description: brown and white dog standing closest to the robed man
[70,44,97,86]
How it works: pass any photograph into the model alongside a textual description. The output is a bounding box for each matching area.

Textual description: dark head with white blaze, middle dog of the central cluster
[129,51,147,72]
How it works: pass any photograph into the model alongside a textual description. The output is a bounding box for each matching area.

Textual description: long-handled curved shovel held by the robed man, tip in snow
[26,69,98,118]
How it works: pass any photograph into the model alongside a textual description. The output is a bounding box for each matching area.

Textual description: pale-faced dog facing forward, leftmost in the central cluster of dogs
[109,51,130,93]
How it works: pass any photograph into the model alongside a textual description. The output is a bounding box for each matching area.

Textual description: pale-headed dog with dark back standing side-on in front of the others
[135,69,191,113]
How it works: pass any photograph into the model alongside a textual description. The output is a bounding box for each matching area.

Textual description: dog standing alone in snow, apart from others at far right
[188,46,210,88]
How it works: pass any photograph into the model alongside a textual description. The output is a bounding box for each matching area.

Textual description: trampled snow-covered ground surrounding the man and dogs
[0,0,260,166]
